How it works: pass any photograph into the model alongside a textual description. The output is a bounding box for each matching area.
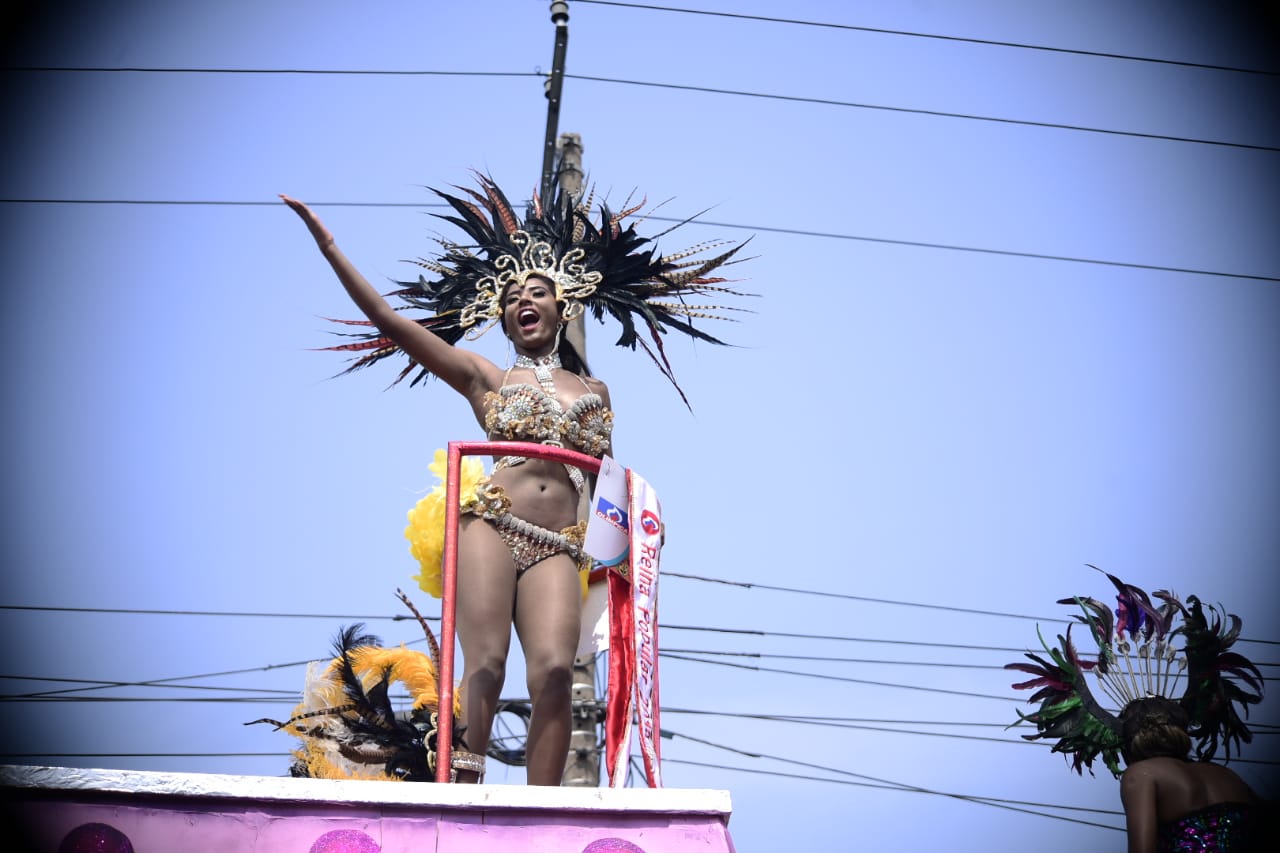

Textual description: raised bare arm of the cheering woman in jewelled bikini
[280,193,499,401]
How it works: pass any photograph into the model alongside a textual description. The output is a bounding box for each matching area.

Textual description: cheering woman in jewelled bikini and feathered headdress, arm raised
[282,175,741,785]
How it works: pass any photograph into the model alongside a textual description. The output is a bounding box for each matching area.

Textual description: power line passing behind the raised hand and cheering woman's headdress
[0,199,1280,282]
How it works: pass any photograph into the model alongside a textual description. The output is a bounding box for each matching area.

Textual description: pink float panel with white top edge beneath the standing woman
[0,767,733,853]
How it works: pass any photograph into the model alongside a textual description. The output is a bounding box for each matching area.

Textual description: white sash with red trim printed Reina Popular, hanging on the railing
[604,469,662,788]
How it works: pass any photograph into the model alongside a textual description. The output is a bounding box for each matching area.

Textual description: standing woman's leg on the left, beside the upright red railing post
[456,517,516,781]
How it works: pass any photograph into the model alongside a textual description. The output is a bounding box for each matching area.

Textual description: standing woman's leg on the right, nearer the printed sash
[516,553,582,785]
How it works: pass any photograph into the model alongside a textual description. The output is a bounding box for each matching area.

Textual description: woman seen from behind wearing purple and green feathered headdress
[1006,563,1276,853]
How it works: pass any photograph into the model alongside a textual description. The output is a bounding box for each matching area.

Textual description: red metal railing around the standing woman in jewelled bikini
[435,442,600,783]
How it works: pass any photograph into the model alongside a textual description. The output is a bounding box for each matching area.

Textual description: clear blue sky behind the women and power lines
[0,0,1280,850]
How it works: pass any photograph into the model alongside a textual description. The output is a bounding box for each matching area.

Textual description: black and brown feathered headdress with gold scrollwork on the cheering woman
[324,174,749,397]
